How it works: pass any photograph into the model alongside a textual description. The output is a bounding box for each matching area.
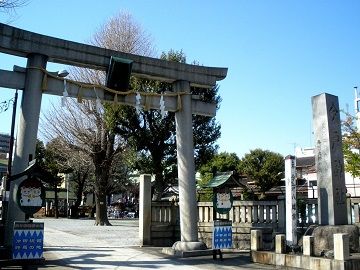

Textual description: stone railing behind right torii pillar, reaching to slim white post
[150,198,285,249]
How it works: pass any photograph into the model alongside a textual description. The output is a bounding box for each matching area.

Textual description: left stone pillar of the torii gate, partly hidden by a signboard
[5,54,47,246]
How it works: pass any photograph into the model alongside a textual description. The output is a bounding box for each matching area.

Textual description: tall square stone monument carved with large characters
[312,93,347,225]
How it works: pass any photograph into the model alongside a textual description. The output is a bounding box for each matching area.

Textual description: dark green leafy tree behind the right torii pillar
[115,50,220,200]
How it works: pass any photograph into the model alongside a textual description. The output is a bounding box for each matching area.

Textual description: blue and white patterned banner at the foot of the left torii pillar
[12,222,44,260]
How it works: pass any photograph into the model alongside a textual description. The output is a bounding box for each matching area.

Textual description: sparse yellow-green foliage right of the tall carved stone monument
[342,113,360,177]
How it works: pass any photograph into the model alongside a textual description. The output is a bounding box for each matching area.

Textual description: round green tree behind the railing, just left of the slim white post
[238,149,284,196]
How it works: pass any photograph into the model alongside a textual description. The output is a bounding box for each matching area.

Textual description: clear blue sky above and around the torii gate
[0,0,360,158]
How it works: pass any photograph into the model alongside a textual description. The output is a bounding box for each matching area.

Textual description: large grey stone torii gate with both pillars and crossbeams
[0,24,227,250]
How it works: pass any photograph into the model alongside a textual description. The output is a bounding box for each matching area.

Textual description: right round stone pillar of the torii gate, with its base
[173,81,206,251]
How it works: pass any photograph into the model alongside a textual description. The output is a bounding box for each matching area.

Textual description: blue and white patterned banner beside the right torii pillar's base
[212,220,232,249]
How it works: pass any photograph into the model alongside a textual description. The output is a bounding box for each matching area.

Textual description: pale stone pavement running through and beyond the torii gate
[34,219,279,270]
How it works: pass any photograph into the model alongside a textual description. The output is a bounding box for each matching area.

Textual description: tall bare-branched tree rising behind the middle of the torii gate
[40,13,153,225]
